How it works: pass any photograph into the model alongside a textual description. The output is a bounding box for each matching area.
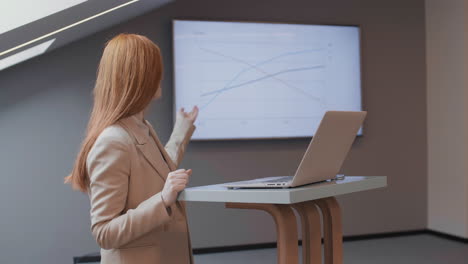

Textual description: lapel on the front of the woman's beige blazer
[120,116,170,181]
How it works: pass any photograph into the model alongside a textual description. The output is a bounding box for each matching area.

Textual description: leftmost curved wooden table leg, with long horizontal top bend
[225,203,299,264]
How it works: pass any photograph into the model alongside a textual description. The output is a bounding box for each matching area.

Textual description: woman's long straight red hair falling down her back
[65,34,163,192]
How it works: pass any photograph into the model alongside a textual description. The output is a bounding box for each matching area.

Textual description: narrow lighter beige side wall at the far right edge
[426,0,468,238]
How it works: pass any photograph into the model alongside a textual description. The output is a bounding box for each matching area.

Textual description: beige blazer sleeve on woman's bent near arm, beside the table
[87,134,170,249]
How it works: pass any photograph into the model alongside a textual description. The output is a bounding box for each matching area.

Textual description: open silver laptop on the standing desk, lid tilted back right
[223,111,367,189]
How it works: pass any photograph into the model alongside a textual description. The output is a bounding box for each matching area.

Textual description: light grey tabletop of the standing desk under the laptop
[178,176,387,204]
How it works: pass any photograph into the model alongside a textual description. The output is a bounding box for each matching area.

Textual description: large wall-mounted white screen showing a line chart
[173,20,362,140]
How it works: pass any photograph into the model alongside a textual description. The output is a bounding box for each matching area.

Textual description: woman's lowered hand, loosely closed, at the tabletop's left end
[161,169,192,206]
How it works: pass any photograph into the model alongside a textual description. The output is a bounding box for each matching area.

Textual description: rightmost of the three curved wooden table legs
[314,197,343,264]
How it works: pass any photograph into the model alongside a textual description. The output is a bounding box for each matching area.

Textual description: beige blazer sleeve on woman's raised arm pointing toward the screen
[164,117,196,167]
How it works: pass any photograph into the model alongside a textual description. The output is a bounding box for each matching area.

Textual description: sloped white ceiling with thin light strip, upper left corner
[0,0,173,71]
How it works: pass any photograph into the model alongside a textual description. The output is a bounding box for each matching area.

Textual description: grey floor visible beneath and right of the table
[195,235,468,264]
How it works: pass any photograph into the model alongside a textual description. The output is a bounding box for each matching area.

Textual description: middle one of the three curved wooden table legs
[291,202,322,264]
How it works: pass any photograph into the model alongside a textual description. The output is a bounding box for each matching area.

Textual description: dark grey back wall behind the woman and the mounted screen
[0,0,427,263]
